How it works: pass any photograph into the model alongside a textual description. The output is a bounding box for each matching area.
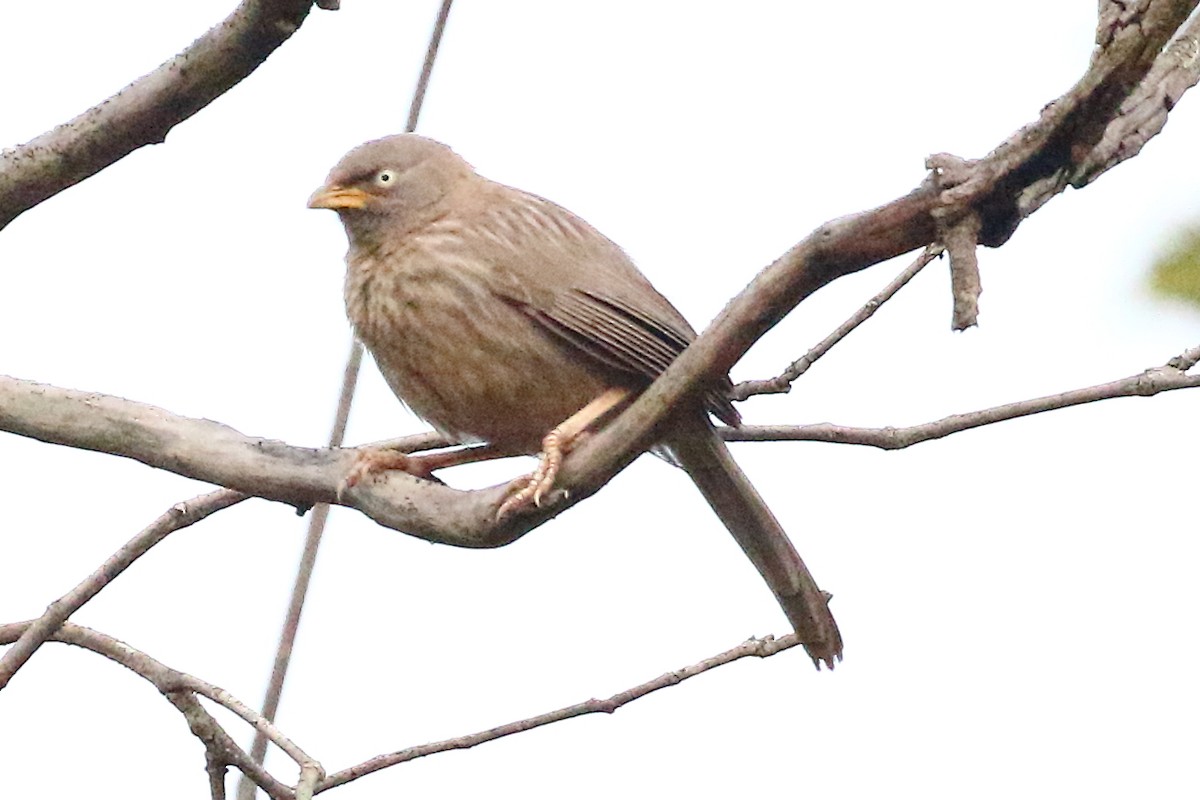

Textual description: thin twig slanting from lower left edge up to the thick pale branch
[0,489,247,690]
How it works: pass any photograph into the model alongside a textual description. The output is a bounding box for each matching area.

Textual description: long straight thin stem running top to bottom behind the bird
[238,0,454,800]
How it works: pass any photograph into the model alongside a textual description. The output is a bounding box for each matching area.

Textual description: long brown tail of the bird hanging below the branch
[670,420,841,669]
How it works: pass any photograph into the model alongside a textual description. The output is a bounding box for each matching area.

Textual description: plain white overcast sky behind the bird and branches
[0,0,1200,799]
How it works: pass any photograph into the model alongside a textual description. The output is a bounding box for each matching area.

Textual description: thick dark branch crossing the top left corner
[0,0,326,229]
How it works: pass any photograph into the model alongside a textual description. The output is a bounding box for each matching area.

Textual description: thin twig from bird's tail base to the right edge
[719,347,1200,450]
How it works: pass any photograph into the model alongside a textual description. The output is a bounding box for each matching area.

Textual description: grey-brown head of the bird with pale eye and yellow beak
[308,133,475,247]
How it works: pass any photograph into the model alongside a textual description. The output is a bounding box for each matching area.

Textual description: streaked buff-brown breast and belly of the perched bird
[347,262,610,452]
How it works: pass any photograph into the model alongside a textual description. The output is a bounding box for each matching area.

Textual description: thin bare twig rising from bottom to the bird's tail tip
[318,633,800,792]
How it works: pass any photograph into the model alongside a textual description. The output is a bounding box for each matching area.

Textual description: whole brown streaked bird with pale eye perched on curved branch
[308,133,842,669]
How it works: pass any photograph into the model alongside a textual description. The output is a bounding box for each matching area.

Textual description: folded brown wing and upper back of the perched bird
[468,185,739,425]
